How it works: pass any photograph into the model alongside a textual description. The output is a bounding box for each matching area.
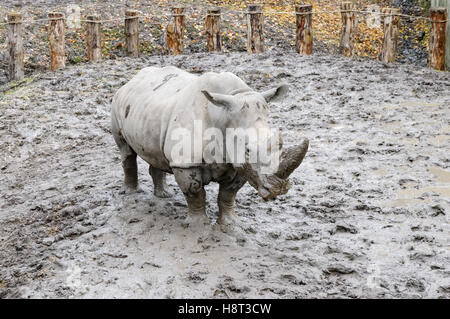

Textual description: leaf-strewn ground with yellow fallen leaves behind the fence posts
[0,1,446,82]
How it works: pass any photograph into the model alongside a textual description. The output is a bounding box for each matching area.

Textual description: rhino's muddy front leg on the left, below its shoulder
[173,168,210,224]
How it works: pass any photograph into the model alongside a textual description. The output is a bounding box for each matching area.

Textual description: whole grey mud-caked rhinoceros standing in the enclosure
[111,66,309,224]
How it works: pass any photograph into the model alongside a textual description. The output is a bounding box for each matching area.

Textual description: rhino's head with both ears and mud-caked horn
[202,84,309,200]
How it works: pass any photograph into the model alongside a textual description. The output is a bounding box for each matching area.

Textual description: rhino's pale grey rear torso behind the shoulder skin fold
[111,67,197,170]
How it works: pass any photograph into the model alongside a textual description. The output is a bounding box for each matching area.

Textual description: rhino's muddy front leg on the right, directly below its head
[217,175,246,225]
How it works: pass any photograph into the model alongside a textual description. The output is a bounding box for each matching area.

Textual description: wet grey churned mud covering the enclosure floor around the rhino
[0,49,450,298]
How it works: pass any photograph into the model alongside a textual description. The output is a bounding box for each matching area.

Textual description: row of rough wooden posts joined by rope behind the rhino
[1,2,447,80]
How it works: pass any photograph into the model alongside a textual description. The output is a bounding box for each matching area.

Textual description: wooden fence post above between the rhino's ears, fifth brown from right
[247,4,264,53]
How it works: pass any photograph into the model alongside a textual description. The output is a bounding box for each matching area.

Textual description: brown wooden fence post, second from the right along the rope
[380,8,400,63]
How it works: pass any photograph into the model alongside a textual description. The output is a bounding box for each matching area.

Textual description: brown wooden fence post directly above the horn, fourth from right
[295,4,313,55]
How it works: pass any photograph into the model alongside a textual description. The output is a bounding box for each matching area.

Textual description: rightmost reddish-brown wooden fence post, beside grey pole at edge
[428,8,447,71]
